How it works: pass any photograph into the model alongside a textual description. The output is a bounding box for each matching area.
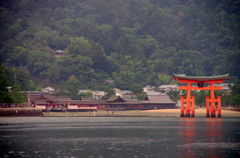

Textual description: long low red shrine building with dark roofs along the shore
[24,91,176,111]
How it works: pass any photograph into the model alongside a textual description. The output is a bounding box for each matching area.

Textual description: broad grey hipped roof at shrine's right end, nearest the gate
[142,95,175,104]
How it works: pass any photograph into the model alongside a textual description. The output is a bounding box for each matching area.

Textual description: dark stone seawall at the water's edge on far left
[0,108,44,117]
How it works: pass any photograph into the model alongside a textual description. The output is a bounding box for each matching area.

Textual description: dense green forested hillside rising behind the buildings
[0,0,240,90]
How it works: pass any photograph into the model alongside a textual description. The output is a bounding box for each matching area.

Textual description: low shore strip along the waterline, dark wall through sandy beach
[0,108,240,118]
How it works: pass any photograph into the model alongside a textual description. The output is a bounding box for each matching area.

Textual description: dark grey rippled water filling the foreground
[0,117,240,158]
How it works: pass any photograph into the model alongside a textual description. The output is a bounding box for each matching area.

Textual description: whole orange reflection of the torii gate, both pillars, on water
[178,118,223,158]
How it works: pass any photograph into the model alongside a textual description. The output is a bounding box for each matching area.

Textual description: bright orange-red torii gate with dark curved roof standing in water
[172,74,229,117]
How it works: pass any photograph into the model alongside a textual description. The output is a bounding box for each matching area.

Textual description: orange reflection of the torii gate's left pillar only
[179,118,197,158]
